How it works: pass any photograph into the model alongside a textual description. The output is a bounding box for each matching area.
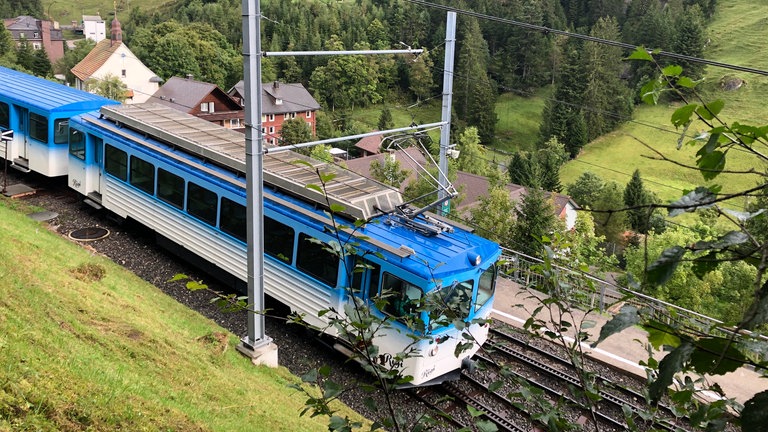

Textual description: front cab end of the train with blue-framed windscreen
[350,213,501,387]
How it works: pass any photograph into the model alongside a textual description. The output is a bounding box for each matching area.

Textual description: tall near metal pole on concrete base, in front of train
[242,0,271,350]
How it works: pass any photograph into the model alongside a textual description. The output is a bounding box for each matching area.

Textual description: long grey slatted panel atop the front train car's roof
[101,103,403,220]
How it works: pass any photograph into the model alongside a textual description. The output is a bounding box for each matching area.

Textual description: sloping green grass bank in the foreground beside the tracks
[0,199,368,432]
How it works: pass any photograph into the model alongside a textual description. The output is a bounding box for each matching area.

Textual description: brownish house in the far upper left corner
[3,15,64,63]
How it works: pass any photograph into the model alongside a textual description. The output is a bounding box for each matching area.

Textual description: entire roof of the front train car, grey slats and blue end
[83,103,499,279]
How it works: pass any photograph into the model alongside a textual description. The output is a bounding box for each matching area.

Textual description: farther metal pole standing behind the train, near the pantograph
[439,12,456,215]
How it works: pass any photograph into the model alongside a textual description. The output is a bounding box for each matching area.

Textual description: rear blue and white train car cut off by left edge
[0,67,119,177]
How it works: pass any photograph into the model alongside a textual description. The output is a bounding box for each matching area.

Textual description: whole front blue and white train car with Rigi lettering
[0,66,501,386]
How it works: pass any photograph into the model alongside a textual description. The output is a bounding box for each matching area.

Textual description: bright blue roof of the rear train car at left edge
[0,67,119,113]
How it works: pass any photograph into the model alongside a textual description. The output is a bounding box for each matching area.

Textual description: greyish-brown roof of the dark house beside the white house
[147,77,242,113]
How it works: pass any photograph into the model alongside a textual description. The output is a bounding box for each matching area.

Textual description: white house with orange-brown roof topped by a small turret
[72,16,162,103]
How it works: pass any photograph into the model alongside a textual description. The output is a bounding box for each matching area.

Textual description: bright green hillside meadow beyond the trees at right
[561,0,768,206]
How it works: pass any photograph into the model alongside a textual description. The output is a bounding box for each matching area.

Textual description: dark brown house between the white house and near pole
[149,75,245,129]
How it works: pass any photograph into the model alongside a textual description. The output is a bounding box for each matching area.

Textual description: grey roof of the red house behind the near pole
[227,81,321,114]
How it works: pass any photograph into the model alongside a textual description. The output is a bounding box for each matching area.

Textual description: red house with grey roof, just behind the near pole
[227,81,320,145]
